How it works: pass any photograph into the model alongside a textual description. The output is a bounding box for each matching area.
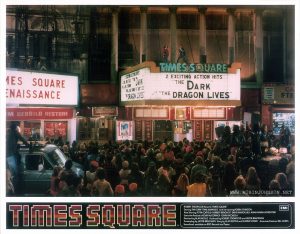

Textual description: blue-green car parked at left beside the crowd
[17,144,84,196]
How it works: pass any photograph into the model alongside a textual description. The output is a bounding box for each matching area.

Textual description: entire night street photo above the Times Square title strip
[6,5,295,197]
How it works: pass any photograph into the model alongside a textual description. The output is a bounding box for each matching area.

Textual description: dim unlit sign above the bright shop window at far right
[263,84,295,105]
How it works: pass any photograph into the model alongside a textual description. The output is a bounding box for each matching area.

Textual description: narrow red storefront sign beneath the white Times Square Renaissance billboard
[6,108,74,121]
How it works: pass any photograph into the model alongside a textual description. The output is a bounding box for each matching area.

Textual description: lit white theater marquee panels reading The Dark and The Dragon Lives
[121,66,240,101]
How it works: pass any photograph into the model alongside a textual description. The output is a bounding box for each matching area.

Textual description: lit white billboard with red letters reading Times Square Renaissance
[6,70,79,106]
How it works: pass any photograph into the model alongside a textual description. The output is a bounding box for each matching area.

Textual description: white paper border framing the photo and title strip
[0,0,300,234]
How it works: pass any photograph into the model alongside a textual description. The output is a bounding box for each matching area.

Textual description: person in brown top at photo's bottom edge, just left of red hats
[92,167,114,197]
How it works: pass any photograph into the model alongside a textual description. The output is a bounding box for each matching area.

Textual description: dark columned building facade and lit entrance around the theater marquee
[6,6,295,141]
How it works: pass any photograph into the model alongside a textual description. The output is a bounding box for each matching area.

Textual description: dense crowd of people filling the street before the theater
[45,124,295,197]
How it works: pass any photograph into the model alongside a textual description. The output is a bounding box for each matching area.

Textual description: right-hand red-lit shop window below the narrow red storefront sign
[44,121,68,141]
